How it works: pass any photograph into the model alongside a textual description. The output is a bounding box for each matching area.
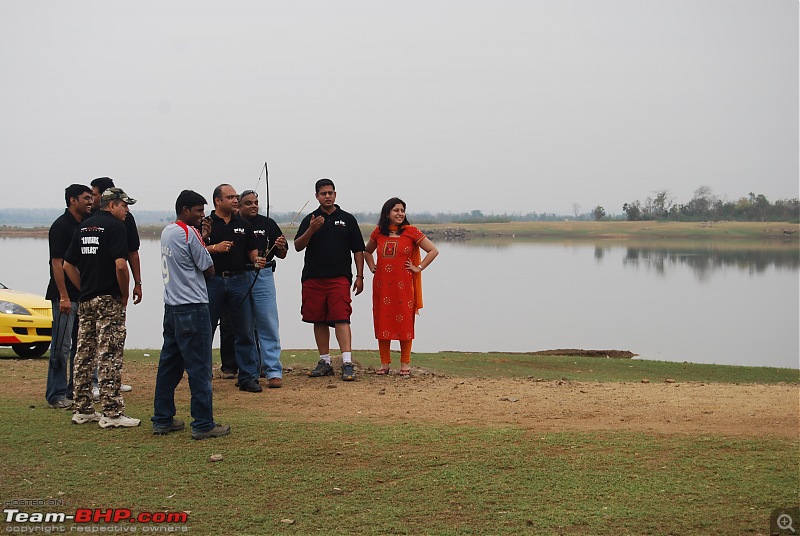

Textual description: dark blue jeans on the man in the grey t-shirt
[151,303,216,432]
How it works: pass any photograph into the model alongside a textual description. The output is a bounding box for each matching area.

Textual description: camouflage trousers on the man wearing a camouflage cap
[74,296,126,417]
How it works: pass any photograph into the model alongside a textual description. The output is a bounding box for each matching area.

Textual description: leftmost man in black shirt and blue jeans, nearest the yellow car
[44,184,92,409]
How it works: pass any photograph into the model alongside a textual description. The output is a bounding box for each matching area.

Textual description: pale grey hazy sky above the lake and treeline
[0,0,799,214]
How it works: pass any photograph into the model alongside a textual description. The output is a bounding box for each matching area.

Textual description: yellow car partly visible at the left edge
[0,283,53,357]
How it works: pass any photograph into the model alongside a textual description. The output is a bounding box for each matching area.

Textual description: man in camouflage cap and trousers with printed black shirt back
[64,188,139,428]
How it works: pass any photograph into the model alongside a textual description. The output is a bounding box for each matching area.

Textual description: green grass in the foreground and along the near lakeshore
[0,349,800,535]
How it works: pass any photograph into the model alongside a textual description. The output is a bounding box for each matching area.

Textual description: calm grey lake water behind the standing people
[0,234,800,368]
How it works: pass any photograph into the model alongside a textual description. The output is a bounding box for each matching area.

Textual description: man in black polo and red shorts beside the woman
[294,179,364,381]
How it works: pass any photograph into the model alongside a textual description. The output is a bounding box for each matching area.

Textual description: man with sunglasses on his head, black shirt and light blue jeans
[239,190,287,389]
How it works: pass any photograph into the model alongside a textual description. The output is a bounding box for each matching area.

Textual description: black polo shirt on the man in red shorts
[295,205,364,282]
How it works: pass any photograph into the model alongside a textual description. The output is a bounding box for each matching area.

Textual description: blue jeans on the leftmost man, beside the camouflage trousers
[44,301,78,404]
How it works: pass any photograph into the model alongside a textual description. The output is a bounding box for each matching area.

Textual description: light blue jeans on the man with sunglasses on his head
[255,268,283,379]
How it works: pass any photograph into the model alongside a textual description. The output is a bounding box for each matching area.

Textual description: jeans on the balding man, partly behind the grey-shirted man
[206,272,259,384]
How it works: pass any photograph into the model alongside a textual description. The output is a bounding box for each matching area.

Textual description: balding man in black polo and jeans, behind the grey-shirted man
[206,184,266,393]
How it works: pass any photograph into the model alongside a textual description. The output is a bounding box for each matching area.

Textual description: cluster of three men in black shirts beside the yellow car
[45,177,142,428]
